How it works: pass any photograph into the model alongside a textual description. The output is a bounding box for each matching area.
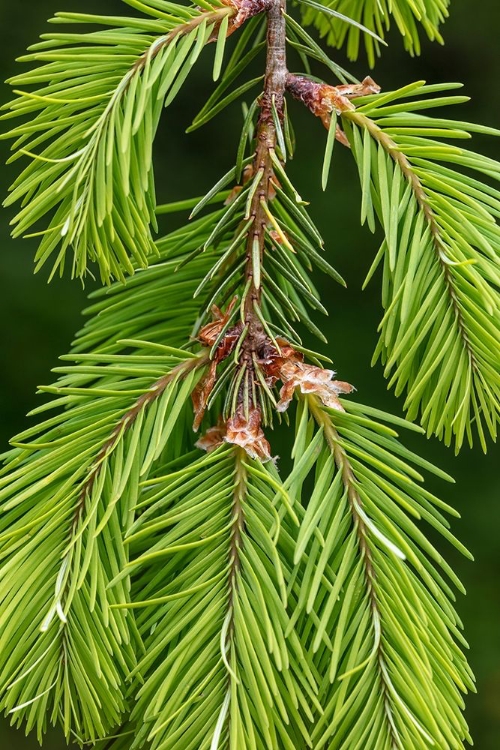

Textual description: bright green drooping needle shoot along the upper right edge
[346,82,500,450]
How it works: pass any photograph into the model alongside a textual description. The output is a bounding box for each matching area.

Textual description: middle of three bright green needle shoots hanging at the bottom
[121,448,317,750]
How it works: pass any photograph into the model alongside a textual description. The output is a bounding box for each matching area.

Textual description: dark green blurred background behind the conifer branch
[0,0,500,750]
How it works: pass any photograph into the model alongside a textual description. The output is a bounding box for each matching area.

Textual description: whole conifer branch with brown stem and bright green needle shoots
[0,0,500,750]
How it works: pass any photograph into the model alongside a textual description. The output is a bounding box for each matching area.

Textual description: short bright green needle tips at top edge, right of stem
[299,0,450,67]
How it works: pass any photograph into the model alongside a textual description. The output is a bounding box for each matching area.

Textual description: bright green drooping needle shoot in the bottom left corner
[0,342,203,740]
